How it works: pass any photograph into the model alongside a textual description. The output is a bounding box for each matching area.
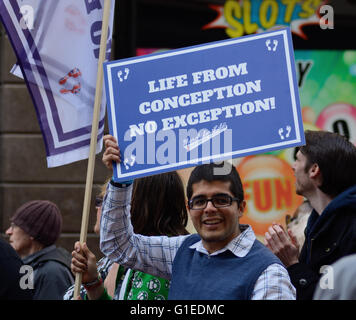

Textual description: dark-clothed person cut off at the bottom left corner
[0,238,33,300]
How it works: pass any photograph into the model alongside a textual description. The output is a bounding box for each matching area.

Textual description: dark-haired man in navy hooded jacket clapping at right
[265,131,356,300]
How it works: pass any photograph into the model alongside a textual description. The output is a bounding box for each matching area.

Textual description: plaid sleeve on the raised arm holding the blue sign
[100,183,189,279]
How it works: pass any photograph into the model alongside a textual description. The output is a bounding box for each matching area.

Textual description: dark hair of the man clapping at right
[299,130,356,197]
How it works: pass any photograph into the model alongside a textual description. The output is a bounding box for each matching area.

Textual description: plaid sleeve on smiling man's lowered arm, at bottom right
[251,263,296,300]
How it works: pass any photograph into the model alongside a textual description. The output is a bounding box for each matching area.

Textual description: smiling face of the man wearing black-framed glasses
[188,180,245,253]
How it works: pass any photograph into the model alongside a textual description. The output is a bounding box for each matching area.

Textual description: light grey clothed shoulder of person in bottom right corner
[313,254,356,300]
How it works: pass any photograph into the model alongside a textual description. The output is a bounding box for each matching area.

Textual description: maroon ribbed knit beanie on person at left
[11,200,62,247]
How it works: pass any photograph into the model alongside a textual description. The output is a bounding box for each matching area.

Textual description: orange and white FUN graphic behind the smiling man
[237,154,303,239]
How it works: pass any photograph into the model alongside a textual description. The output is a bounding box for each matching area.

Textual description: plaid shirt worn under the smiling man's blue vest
[100,184,296,300]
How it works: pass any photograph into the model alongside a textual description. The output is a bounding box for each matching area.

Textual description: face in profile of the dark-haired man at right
[292,151,313,196]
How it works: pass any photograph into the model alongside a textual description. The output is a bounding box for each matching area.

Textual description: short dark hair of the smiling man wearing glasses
[187,162,244,203]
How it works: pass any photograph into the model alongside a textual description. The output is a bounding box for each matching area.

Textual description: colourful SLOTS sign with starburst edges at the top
[203,0,328,39]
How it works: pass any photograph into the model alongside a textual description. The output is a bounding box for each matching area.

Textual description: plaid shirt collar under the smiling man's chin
[189,224,256,258]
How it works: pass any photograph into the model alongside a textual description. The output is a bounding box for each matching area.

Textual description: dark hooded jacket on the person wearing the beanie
[23,245,74,300]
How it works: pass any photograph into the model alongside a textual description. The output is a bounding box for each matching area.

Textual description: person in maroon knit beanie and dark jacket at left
[6,200,74,300]
